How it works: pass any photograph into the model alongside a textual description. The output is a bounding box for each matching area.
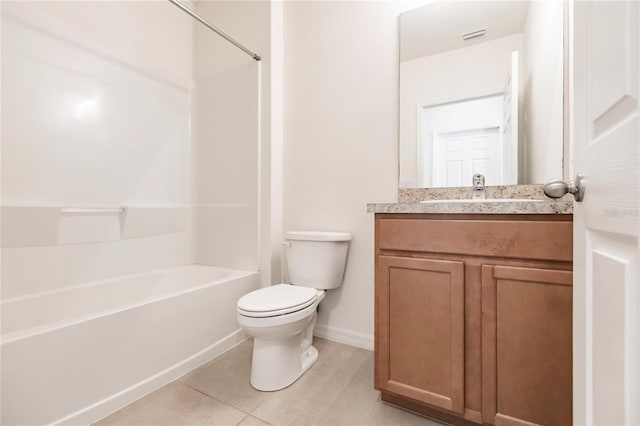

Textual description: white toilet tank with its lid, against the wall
[285,231,351,290]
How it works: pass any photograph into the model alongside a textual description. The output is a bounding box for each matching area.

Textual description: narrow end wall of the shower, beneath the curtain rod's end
[192,2,269,270]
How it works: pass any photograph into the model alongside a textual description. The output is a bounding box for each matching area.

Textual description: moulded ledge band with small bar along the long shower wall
[1,205,188,248]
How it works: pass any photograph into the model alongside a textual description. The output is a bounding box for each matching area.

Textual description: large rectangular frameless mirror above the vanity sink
[399,0,565,188]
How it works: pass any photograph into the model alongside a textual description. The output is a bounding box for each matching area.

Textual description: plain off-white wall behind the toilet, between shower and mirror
[283,1,402,347]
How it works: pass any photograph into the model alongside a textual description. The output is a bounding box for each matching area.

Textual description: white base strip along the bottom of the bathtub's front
[53,329,247,425]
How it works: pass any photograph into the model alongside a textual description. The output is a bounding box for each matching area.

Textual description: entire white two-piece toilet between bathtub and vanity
[238,231,351,391]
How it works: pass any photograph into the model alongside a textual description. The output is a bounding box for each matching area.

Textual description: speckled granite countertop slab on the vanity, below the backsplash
[367,200,573,214]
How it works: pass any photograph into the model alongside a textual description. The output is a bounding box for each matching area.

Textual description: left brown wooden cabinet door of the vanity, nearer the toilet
[376,256,464,414]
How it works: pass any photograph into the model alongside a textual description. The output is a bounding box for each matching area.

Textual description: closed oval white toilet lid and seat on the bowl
[238,284,318,317]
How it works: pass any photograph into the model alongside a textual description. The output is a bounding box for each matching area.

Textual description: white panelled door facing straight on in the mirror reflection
[433,127,503,187]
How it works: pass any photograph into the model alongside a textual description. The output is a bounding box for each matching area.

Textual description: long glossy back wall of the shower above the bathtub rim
[1,1,193,298]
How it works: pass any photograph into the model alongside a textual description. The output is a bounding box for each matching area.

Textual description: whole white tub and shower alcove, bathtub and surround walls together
[0,1,269,425]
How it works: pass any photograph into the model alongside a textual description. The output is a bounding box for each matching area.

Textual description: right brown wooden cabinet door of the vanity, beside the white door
[482,265,572,426]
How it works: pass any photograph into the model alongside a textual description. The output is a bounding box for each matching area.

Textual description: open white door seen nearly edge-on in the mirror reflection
[501,52,522,185]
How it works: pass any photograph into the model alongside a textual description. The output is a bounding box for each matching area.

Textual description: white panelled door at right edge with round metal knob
[570,1,640,425]
